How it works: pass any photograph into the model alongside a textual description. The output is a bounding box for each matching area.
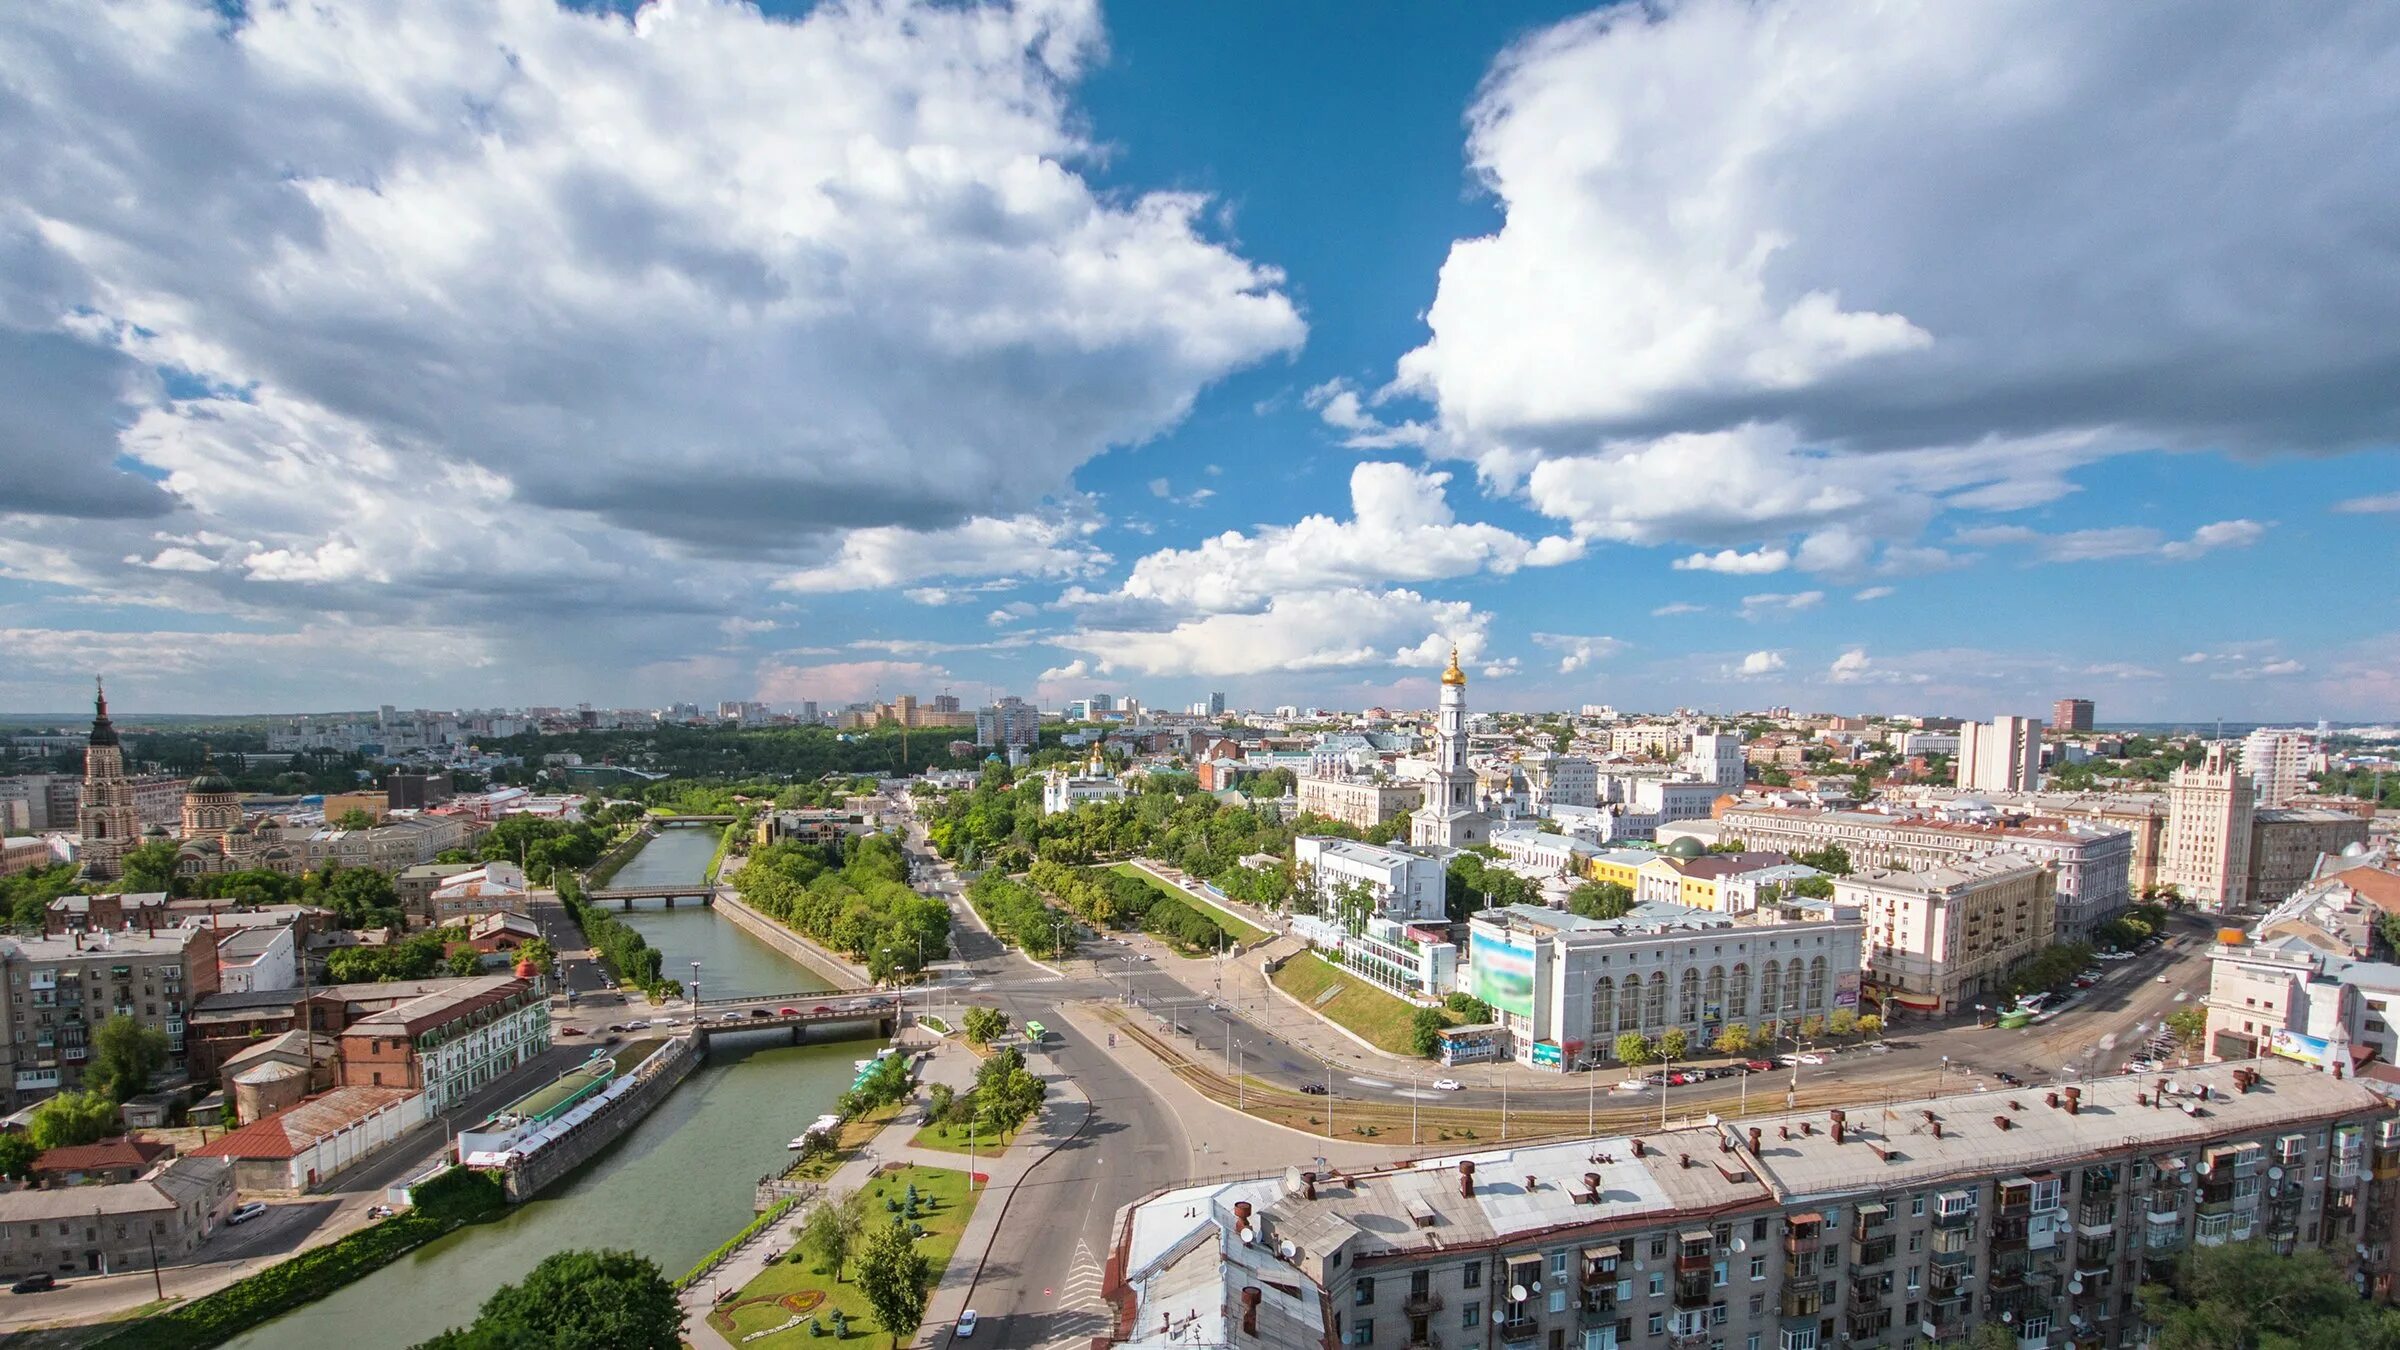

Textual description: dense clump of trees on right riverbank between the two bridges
[734,834,950,980]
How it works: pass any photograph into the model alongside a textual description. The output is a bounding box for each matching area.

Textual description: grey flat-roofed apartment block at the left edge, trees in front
[0,927,216,1110]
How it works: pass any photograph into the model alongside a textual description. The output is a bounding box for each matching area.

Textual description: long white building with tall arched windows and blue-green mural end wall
[1469,903,1860,1071]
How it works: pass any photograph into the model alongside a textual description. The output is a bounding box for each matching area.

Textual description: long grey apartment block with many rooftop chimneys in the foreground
[1104,1064,2400,1350]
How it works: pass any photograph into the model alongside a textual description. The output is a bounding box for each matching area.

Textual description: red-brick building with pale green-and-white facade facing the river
[341,975,550,1115]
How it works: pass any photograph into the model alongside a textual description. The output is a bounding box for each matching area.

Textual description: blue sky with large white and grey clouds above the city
[0,0,2400,721]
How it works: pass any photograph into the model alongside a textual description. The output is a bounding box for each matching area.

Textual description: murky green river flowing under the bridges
[230,829,862,1350]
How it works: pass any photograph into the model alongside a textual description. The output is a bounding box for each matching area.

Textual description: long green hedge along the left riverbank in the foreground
[94,1167,506,1350]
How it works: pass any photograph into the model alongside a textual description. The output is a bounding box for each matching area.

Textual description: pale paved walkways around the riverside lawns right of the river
[679,1043,1092,1350]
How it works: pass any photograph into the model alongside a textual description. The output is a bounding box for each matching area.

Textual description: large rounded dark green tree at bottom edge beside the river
[420,1249,684,1350]
